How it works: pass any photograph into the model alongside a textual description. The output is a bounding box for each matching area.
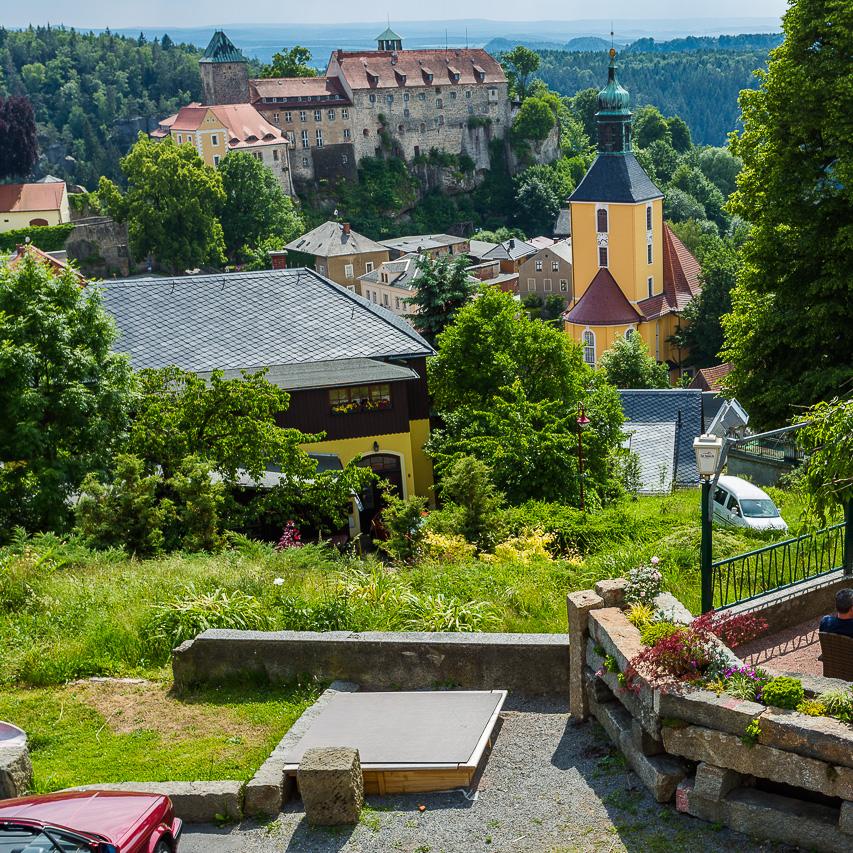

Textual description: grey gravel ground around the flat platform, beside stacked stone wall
[181,697,788,853]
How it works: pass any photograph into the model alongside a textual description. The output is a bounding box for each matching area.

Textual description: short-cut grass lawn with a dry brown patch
[0,681,319,793]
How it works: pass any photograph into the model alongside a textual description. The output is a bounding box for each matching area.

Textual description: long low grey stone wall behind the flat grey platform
[172,630,569,695]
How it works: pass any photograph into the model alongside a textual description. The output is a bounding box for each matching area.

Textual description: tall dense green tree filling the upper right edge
[723,0,853,427]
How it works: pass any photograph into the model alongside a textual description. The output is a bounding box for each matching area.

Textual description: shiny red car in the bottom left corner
[0,791,181,853]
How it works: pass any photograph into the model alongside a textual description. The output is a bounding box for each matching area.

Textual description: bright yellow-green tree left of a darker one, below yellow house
[98,133,225,273]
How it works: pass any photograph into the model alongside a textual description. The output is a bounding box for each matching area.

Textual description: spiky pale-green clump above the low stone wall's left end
[148,584,270,653]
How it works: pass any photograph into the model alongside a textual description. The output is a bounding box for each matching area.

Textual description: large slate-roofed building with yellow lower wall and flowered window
[98,268,433,523]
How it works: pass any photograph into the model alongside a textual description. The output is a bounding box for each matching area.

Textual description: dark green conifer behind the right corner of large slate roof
[406,254,474,341]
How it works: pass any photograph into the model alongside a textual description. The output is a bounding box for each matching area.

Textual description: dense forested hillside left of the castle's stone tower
[0,27,201,189]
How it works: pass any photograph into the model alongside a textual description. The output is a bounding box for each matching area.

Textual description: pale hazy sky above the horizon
[0,0,787,29]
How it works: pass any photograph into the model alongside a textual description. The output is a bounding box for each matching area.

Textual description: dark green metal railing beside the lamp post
[711,521,845,609]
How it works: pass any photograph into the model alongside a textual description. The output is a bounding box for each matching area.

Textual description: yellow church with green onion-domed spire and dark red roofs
[563,51,700,378]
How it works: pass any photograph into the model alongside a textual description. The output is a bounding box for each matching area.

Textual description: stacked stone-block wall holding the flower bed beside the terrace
[568,581,853,853]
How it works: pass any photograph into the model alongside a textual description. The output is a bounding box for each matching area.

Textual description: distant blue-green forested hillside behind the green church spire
[537,48,768,145]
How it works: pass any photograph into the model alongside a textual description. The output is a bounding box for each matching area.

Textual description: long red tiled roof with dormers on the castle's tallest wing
[330,48,506,89]
